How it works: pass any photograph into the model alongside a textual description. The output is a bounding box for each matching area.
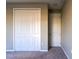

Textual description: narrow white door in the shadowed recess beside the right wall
[49,13,61,47]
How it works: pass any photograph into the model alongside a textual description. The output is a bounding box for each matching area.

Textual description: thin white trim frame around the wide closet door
[12,8,41,51]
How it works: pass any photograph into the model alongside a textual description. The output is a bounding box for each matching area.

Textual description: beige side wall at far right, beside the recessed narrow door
[61,0,72,59]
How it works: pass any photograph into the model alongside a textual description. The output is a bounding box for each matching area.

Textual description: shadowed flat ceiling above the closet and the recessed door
[6,0,64,9]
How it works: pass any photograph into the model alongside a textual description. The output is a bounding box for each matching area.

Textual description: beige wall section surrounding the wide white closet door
[6,3,48,50]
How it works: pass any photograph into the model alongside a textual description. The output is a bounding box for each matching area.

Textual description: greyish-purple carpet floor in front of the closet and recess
[6,47,67,59]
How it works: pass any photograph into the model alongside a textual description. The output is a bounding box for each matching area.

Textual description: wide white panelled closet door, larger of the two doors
[13,8,41,51]
